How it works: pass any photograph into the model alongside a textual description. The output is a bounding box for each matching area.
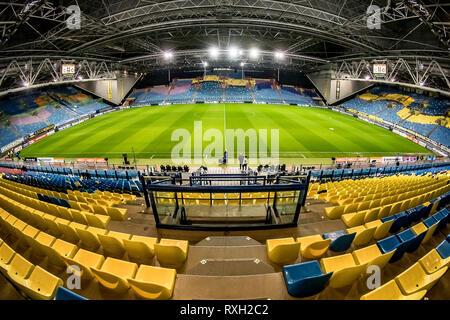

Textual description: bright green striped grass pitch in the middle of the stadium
[21,104,431,165]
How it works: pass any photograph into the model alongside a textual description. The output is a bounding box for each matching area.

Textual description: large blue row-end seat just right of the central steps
[283,260,333,298]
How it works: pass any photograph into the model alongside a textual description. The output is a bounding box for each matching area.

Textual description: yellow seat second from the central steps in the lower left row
[91,257,138,294]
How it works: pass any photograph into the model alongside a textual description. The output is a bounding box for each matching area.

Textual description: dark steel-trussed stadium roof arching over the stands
[0,0,450,94]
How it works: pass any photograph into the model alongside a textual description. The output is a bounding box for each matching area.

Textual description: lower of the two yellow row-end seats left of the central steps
[128,265,177,300]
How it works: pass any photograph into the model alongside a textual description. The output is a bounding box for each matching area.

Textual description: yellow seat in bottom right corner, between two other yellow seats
[395,262,448,294]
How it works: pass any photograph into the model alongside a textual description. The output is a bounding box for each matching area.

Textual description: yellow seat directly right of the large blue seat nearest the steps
[320,253,366,288]
